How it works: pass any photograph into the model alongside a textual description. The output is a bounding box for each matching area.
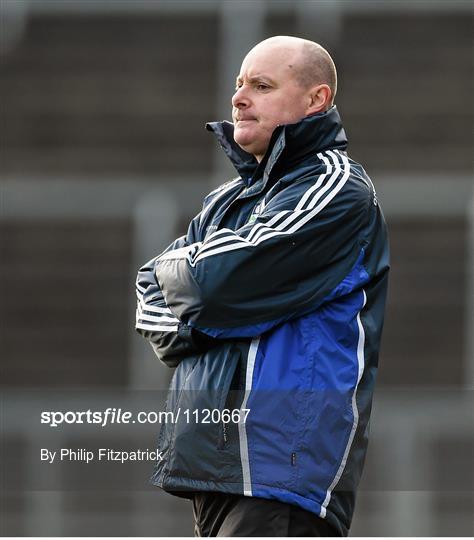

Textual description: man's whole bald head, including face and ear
[232,36,336,161]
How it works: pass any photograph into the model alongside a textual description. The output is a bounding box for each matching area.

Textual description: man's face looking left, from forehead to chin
[232,45,309,161]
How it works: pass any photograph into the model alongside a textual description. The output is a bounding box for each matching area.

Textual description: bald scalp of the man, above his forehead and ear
[249,36,337,105]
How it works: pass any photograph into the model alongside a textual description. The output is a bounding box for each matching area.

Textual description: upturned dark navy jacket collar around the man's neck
[206,106,347,185]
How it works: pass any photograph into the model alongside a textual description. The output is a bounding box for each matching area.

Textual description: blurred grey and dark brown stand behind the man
[0,0,474,536]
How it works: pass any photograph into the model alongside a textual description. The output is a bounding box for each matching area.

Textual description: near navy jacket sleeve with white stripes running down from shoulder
[155,158,371,338]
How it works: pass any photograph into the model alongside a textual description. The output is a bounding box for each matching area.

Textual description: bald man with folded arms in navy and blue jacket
[136,36,388,536]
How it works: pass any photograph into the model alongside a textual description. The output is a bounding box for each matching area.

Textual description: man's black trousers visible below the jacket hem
[193,492,338,537]
